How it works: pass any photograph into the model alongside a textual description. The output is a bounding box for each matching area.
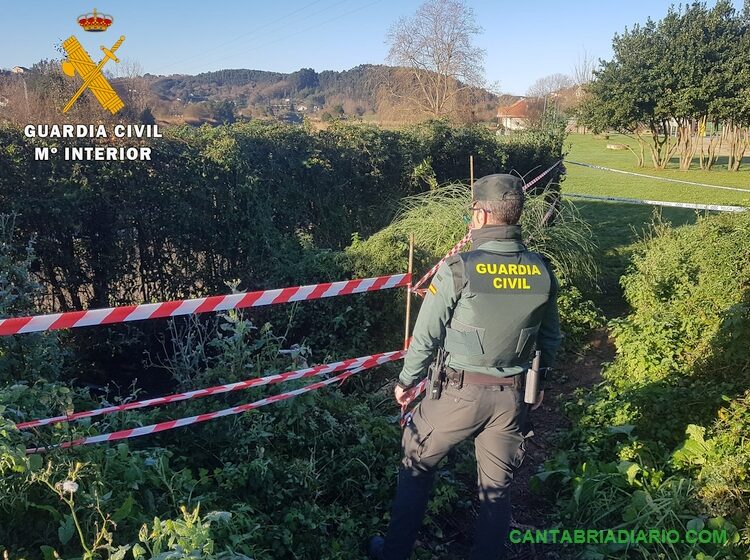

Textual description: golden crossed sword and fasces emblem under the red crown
[62,35,125,115]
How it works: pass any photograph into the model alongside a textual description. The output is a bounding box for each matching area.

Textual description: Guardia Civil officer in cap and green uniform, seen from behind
[370,174,562,560]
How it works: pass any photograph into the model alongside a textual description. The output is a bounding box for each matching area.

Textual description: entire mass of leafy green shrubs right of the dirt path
[539,213,750,559]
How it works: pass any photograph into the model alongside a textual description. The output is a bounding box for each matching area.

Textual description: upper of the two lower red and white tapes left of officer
[16,350,405,430]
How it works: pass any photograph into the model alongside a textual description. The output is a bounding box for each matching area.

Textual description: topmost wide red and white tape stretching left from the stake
[0,274,411,336]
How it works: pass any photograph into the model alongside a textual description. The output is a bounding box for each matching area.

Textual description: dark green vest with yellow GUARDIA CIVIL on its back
[445,248,552,367]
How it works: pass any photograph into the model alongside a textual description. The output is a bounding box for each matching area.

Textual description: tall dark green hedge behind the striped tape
[0,121,562,310]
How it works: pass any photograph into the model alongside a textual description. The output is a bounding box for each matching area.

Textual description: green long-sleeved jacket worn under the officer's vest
[399,226,562,387]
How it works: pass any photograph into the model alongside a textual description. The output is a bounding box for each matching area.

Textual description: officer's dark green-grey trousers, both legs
[384,378,532,560]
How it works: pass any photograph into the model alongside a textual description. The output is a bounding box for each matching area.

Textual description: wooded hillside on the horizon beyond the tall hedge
[0,60,500,125]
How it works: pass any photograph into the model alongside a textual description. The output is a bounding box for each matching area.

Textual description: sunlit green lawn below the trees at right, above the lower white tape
[563,134,750,206]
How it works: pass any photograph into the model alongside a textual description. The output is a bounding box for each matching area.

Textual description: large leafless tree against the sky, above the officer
[387,0,485,117]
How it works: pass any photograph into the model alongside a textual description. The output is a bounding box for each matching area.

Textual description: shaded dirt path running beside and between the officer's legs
[433,328,615,560]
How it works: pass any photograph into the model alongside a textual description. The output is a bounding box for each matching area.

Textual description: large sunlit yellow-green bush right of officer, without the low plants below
[572,213,750,462]
